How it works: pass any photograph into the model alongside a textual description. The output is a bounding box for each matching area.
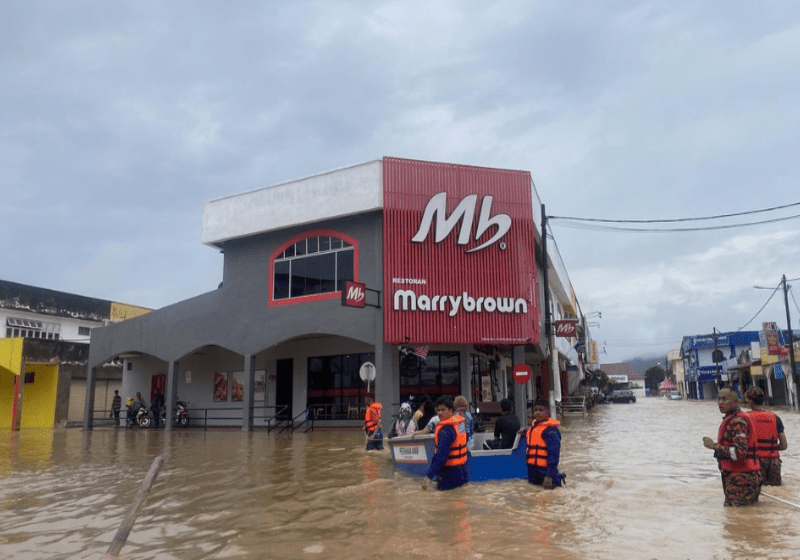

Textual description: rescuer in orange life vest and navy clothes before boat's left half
[422,396,469,490]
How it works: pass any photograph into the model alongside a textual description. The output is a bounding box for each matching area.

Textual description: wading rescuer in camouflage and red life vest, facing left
[703,387,761,506]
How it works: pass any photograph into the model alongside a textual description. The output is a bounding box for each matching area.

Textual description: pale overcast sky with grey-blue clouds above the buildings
[0,0,800,362]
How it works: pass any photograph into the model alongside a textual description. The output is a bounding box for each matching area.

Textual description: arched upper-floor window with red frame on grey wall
[270,230,358,305]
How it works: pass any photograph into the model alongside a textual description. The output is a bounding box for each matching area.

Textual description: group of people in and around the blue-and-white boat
[364,395,565,490]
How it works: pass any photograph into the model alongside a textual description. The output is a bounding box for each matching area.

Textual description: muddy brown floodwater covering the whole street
[0,398,800,560]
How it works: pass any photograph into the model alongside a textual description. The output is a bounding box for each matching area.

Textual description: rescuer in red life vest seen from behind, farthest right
[745,386,789,486]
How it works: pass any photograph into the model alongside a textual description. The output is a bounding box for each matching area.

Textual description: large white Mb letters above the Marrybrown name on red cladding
[411,192,511,253]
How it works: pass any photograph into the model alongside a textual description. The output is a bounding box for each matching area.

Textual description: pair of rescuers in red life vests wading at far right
[703,386,788,506]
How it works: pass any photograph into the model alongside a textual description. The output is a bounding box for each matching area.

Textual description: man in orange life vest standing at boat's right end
[519,399,566,490]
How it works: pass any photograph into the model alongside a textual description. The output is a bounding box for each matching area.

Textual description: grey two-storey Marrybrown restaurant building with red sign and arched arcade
[84,157,574,430]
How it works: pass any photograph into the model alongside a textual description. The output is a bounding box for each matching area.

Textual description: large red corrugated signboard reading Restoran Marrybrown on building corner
[383,154,539,345]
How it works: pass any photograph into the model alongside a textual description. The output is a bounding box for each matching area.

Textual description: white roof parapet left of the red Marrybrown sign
[202,159,383,247]
